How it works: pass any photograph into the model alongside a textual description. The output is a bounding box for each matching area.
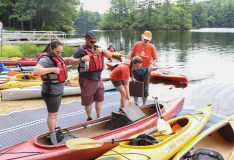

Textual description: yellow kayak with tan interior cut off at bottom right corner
[173,115,234,160]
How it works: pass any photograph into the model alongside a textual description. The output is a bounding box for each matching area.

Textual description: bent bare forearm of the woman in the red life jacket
[34,64,61,76]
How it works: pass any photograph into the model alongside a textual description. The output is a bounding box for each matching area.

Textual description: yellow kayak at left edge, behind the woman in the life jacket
[0,74,42,90]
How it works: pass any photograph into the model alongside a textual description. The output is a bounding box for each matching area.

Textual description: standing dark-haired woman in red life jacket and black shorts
[34,40,67,131]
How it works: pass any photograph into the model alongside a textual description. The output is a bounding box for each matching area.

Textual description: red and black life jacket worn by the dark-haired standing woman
[37,52,67,84]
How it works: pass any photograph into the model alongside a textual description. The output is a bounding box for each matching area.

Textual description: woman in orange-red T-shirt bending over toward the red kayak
[110,56,143,110]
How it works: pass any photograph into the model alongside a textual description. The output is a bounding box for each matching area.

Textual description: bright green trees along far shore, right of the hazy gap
[98,0,234,30]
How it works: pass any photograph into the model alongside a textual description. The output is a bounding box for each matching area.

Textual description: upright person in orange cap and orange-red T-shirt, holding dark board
[130,31,157,105]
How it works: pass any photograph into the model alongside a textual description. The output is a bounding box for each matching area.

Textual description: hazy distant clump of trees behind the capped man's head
[74,7,102,28]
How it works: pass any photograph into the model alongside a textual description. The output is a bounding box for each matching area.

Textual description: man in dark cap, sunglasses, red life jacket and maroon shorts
[69,32,112,121]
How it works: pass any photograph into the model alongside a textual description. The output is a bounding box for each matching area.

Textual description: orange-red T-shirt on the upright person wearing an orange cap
[132,42,157,67]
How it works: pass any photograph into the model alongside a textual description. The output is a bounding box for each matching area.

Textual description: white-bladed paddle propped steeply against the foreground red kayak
[154,96,172,134]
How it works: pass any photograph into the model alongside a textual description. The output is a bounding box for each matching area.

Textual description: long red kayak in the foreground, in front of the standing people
[0,98,184,160]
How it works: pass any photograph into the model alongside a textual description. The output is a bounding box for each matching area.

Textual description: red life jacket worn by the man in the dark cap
[79,45,105,73]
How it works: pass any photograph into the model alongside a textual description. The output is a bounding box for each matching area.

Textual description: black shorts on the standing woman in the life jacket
[42,93,62,113]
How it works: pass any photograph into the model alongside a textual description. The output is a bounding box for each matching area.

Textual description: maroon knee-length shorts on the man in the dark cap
[79,77,104,106]
